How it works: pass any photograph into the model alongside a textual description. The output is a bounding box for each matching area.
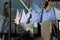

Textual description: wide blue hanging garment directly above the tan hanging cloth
[42,8,55,22]
